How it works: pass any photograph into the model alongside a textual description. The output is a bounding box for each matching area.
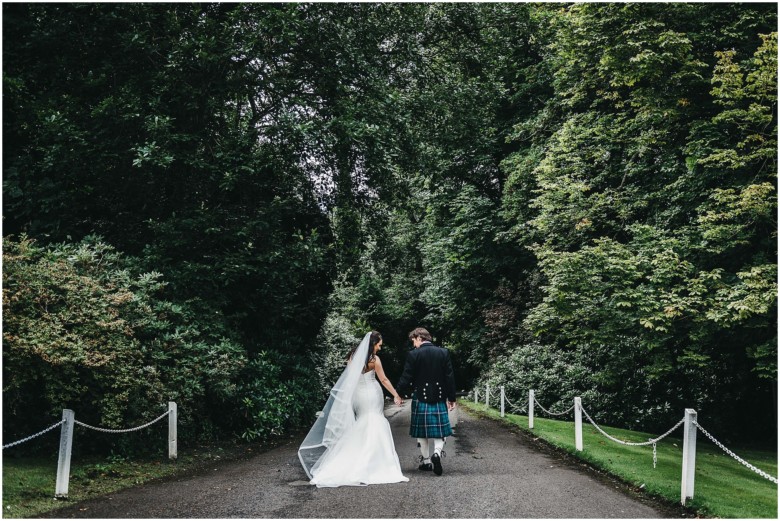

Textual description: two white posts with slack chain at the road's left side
[3,402,178,498]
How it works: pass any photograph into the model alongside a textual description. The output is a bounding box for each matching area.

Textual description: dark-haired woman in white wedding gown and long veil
[298,331,409,487]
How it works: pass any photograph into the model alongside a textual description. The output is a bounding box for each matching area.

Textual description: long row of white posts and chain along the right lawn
[469,385,777,505]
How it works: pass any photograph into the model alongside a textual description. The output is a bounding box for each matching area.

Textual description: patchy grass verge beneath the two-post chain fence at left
[3,445,253,518]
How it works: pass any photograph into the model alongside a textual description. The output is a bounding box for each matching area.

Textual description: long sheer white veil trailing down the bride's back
[298,332,371,479]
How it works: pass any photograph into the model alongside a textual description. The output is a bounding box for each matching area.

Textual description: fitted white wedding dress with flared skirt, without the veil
[310,370,409,487]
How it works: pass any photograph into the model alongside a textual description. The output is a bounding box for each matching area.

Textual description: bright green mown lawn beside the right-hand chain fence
[459,400,777,518]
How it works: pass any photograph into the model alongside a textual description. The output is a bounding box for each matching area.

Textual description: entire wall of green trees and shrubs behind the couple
[3,3,777,446]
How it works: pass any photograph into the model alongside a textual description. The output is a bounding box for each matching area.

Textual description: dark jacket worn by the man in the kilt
[395,342,455,403]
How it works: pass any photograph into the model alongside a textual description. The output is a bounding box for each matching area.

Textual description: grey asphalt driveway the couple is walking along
[47,402,677,518]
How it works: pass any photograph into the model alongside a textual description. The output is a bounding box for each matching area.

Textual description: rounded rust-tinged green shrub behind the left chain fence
[3,236,246,446]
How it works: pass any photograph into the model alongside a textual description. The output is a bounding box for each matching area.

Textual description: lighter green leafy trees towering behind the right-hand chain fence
[490,4,777,436]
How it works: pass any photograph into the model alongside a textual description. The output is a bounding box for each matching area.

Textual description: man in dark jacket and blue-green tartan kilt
[395,327,455,476]
